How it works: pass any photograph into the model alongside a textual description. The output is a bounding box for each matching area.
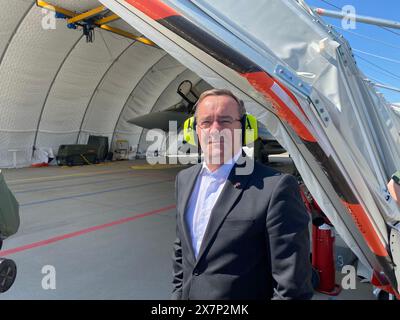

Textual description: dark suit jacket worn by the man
[172,157,313,300]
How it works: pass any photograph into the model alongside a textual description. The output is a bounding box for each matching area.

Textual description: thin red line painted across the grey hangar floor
[0,205,175,257]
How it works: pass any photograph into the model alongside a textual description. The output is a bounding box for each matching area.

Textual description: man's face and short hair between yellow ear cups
[196,96,242,165]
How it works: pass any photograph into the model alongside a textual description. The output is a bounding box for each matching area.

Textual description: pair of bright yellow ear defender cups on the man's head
[183,113,258,146]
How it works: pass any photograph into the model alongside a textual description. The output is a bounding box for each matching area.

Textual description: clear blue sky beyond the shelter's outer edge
[305,0,400,102]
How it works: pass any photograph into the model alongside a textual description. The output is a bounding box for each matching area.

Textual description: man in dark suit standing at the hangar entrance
[172,89,313,300]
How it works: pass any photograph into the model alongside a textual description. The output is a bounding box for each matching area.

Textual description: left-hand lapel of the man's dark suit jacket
[178,164,202,264]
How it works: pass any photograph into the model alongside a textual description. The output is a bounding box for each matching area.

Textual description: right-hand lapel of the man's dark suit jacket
[196,156,253,264]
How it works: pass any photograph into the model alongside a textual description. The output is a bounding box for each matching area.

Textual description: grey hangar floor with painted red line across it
[0,157,373,300]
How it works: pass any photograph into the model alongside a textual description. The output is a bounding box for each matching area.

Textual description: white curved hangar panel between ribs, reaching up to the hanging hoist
[39,31,129,132]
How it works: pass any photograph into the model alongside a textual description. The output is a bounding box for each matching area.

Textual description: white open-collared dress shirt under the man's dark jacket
[186,150,242,258]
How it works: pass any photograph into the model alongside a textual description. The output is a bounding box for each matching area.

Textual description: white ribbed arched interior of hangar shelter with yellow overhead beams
[0,0,209,167]
